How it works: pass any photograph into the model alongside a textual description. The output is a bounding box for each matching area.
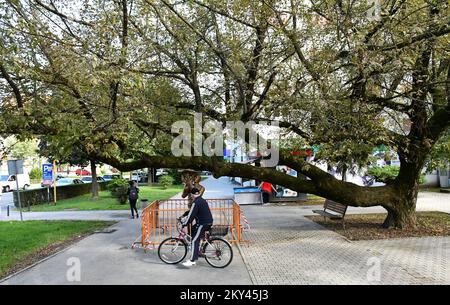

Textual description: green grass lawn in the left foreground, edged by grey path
[0,220,114,278]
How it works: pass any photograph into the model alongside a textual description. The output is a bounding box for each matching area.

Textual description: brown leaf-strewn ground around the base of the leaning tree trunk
[308,212,450,240]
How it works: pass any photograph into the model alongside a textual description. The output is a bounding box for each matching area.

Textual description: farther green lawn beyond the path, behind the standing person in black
[27,185,183,212]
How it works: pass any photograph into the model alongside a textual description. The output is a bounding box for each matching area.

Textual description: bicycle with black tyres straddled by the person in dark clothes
[158,218,233,268]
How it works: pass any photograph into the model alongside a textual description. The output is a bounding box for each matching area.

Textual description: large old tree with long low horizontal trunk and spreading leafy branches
[0,0,450,227]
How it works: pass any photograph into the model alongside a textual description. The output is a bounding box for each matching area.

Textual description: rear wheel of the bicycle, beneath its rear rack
[203,237,233,268]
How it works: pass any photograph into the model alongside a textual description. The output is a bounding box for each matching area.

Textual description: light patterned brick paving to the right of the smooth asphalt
[240,206,450,285]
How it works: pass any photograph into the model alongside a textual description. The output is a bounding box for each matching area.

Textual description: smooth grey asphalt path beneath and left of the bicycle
[0,219,251,285]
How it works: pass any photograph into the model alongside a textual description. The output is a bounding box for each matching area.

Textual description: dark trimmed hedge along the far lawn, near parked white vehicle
[14,182,108,207]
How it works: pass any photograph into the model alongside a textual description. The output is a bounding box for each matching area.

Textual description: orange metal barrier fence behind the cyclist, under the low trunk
[141,199,244,248]
